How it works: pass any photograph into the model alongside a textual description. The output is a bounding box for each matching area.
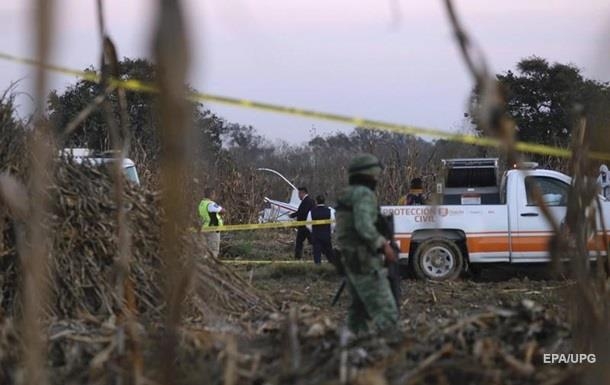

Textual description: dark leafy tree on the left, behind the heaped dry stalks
[47,58,227,171]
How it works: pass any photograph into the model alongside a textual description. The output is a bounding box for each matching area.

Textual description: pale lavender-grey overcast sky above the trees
[0,0,610,143]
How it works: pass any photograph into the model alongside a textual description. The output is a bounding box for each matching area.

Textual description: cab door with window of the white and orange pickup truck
[511,172,569,263]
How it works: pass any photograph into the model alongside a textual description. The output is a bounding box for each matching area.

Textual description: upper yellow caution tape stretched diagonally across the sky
[0,52,610,161]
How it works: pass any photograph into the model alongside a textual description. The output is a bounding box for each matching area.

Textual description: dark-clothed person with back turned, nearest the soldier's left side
[307,195,335,265]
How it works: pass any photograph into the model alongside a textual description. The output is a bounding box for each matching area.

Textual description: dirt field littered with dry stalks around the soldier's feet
[26,228,594,385]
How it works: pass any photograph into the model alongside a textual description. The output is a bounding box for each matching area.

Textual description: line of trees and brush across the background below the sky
[0,57,610,223]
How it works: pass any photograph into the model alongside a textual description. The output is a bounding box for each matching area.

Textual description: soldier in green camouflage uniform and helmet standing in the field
[336,154,398,333]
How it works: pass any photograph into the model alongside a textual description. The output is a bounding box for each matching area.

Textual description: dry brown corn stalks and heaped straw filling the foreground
[0,0,610,385]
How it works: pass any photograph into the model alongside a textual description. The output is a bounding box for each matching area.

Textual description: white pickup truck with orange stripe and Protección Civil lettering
[381,169,610,280]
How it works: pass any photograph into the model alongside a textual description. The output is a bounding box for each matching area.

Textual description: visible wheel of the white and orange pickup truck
[413,239,464,281]
